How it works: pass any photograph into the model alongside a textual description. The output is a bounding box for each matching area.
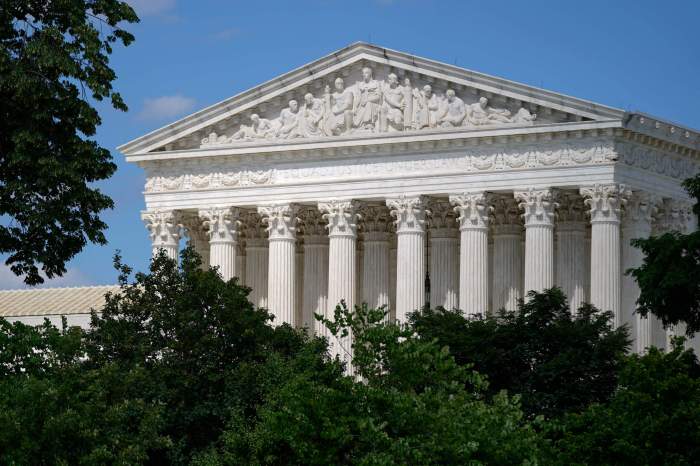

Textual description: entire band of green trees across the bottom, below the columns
[5,250,700,466]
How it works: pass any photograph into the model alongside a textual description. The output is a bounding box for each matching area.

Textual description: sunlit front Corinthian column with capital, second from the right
[514,188,557,294]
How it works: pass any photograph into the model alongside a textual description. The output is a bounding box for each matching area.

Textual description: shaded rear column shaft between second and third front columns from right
[493,224,523,311]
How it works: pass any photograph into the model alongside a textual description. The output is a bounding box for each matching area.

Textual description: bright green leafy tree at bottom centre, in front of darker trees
[196,304,540,465]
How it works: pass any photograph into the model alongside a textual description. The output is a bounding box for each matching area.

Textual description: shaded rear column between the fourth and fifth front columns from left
[360,205,389,309]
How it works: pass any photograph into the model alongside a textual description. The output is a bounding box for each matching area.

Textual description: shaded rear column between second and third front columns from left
[244,212,269,308]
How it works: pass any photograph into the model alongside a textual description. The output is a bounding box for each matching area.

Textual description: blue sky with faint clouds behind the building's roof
[0,0,700,288]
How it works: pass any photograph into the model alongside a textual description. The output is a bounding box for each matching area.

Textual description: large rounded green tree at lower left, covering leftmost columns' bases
[0,250,342,464]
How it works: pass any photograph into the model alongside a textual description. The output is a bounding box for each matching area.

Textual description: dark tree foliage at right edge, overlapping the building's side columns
[629,175,700,335]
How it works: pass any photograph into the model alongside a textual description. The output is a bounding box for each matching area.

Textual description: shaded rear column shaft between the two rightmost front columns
[557,221,586,312]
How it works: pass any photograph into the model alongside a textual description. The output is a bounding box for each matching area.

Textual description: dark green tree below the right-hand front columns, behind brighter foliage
[410,288,630,417]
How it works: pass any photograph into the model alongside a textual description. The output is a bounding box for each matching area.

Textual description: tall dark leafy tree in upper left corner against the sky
[0,0,138,284]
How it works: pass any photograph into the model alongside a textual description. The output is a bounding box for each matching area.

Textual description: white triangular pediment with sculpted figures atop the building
[119,43,624,155]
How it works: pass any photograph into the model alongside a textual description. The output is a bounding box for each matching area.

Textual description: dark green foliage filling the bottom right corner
[548,341,700,465]
